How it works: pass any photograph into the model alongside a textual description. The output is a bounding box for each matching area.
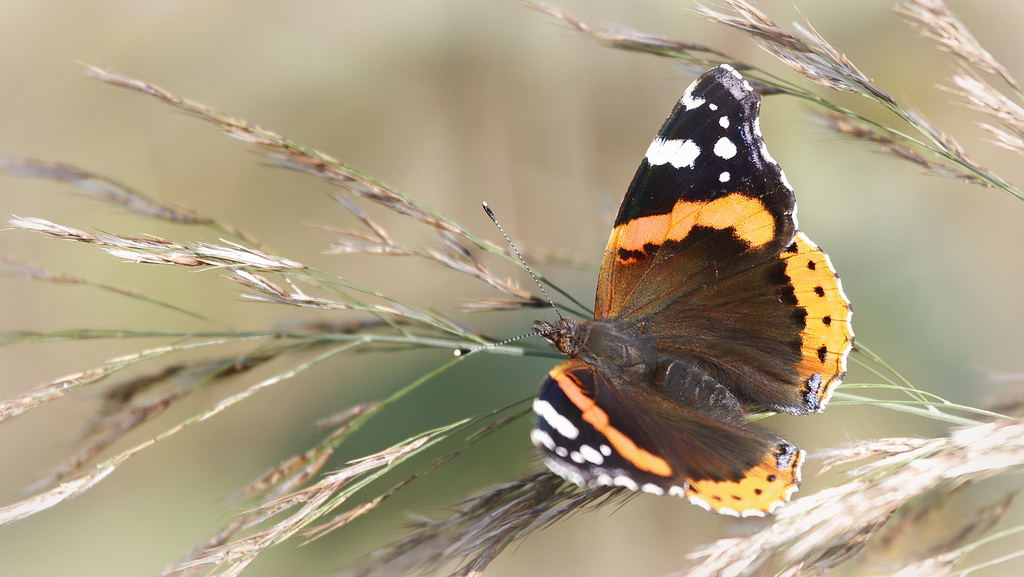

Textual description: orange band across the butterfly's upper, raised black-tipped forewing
[608,193,775,264]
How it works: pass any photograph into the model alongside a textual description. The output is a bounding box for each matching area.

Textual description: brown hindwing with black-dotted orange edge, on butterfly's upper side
[618,228,853,414]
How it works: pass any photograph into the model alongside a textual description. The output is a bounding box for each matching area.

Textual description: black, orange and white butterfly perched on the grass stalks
[530,65,853,517]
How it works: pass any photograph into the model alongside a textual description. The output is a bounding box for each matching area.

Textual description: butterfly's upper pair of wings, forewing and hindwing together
[595,65,853,413]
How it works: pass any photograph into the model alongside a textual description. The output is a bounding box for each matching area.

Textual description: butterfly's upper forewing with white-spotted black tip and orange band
[596,67,796,325]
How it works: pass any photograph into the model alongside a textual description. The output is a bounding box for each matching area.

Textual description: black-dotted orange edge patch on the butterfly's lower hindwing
[686,444,804,517]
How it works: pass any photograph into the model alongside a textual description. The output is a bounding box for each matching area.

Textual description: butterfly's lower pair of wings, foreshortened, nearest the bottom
[530,359,803,517]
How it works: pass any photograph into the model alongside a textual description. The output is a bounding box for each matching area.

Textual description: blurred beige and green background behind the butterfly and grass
[0,0,1024,577]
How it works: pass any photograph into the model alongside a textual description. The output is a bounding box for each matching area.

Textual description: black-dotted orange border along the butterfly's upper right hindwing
[781,233,853,411]
